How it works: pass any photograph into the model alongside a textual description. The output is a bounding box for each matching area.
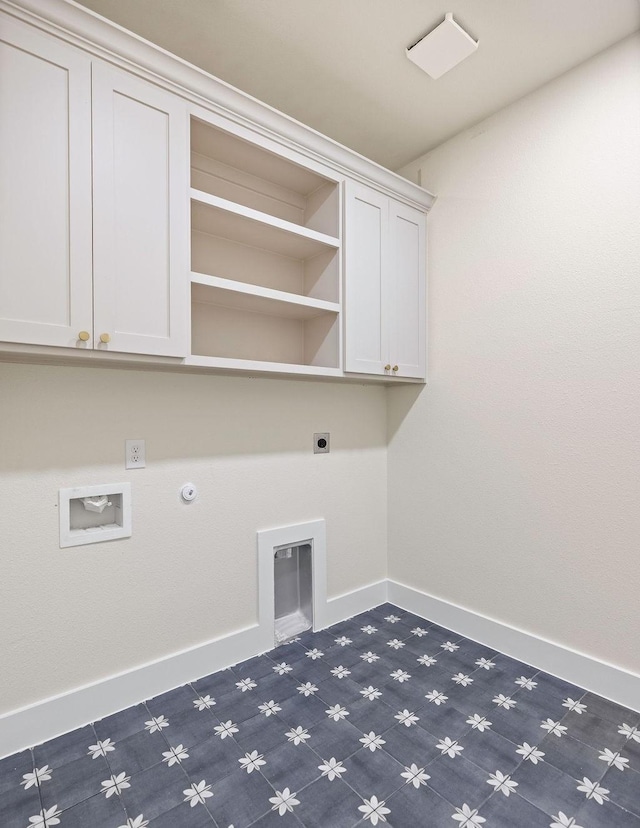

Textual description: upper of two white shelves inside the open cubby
[191,188,340,260]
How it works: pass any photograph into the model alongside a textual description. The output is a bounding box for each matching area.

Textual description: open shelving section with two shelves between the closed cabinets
[188,117,342,375]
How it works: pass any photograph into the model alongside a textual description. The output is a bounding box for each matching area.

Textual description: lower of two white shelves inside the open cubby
[191,273,340,319]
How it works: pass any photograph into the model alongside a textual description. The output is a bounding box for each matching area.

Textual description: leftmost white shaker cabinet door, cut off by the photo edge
[0,14,92,347]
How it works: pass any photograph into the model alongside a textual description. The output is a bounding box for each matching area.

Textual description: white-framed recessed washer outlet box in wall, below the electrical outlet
[58,483,131,549]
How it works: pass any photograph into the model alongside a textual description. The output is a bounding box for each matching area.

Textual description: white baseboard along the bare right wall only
[387,581,640,711]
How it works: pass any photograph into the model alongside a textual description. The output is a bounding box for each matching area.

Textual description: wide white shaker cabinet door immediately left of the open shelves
[93,61,189,357]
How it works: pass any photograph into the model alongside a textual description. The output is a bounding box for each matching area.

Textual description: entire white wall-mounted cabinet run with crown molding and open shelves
[0,0,433,383]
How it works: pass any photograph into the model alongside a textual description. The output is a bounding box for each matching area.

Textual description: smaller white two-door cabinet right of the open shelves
[345,183,426,379]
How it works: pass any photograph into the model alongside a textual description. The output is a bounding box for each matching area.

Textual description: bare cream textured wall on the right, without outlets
[389,36,640,672]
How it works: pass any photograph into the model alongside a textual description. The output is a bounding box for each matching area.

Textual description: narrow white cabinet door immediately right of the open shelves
[344,182,389,374]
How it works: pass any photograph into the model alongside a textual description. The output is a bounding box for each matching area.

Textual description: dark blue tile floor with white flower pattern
[0,604,640,828]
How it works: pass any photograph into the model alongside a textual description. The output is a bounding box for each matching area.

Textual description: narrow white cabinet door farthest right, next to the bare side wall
[389,201,427,379]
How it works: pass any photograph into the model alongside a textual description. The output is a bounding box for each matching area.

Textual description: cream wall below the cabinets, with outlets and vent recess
[0,364,387,714]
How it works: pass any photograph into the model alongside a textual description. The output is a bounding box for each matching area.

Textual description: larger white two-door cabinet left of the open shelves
[0,15,189,357]
